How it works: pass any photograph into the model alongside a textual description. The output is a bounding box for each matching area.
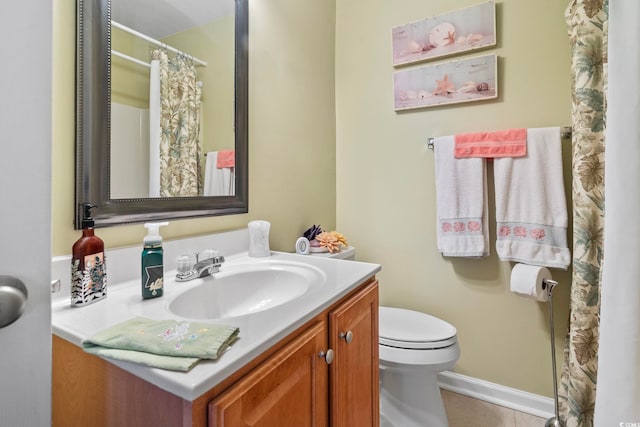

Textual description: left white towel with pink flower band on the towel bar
[434,136,489,258]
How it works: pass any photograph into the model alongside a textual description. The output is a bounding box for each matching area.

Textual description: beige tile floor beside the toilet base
[442,390,547,427]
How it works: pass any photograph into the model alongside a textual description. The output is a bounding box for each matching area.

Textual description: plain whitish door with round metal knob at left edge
[0,0,52,427]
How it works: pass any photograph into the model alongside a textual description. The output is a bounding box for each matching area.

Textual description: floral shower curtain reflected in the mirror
[151,49,202,197]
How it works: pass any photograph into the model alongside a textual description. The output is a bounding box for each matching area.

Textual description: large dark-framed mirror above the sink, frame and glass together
[75,0,248,228]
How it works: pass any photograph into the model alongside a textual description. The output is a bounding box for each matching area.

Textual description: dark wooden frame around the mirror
[75,0,249,229]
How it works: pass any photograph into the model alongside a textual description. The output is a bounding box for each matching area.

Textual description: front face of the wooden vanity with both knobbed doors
[209,281,380,427]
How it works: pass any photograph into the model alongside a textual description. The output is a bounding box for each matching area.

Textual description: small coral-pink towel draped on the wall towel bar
[455,129,527,159]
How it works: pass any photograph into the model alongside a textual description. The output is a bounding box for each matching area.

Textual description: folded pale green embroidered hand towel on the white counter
[82,317,240,371]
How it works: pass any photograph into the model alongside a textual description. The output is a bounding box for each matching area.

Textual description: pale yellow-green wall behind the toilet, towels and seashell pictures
[336,0,570,396]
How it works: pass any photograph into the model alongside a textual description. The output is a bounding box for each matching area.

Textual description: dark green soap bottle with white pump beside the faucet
[142,222,169,299]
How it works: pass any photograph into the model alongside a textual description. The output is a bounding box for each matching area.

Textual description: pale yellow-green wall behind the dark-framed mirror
[52,0,336,256]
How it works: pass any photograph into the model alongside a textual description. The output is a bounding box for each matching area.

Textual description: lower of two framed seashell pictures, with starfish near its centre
[393,53,498,111]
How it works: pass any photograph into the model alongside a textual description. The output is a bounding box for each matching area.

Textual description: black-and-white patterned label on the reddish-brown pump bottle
[71,252,107,305]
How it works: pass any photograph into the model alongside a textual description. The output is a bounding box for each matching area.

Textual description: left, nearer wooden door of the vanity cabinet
[209,322,329,427]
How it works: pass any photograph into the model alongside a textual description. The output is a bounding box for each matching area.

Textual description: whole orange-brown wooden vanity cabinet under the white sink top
[52,278,379,427]
